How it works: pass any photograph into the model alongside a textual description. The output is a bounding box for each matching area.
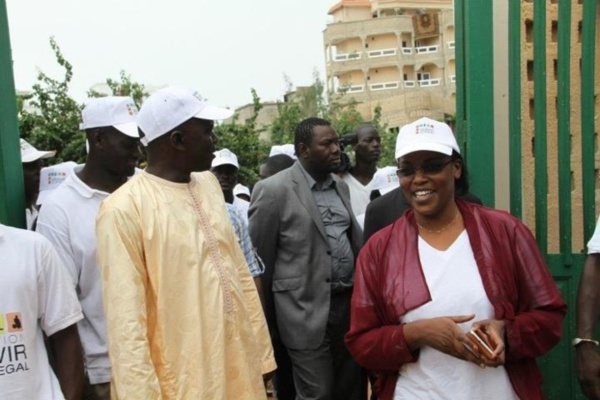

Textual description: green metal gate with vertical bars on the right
[455,0,600,400]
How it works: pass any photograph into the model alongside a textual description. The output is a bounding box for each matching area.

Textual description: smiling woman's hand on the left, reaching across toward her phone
[404,314,486,367]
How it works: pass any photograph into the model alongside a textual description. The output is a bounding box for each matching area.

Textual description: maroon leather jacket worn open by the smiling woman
[345,200,567,400]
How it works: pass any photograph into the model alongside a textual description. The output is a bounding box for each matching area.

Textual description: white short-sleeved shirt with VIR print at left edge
[0,225,83,400]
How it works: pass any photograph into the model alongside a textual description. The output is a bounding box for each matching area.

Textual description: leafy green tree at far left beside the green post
[19,38,85,163]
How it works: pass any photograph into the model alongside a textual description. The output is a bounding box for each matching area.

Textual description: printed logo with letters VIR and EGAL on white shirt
[0,312,29,377]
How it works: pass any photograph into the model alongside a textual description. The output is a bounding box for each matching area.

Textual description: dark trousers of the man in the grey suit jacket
[287,292,367,400]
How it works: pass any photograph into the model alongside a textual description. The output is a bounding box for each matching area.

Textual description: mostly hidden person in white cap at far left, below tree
[21,139,56,229]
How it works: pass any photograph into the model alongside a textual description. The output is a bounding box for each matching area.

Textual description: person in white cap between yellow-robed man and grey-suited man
[210,149,250,224]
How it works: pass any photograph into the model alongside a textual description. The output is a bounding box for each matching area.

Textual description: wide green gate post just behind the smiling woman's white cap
[454,0,496,206]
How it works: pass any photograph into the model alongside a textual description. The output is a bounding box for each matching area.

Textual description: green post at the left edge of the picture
[0,0,25,228]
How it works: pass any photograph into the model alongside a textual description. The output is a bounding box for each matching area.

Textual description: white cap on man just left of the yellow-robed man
[79,96,140,138]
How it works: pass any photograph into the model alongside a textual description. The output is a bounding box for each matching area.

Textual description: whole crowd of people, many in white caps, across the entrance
[0,87,600,400]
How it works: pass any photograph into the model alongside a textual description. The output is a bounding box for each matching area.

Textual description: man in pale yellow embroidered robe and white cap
[96,87,275,400]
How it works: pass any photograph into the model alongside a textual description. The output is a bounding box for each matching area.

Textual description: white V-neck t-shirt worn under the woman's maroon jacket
[394,231,517,400]
